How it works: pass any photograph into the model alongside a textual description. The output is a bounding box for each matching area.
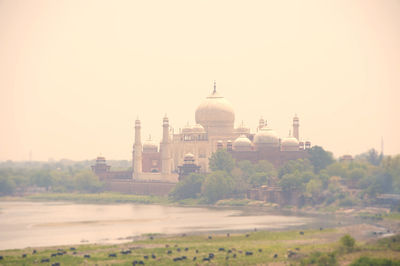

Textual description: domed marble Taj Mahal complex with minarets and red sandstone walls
[92,83,311,188]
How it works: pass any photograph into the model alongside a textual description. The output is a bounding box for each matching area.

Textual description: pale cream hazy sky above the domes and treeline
[0,0,400,160]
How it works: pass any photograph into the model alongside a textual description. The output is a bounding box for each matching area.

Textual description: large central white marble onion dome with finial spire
[195,85,235,133]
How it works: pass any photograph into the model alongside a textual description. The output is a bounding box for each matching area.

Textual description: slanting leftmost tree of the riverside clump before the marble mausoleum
[170,173,204,200]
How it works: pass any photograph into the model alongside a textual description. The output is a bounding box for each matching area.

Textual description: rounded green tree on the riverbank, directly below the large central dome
[201,171,233,203]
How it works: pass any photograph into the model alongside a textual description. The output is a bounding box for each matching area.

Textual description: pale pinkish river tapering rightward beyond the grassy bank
[0,201,313,250]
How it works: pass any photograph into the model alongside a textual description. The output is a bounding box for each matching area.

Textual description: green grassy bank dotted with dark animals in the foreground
[0,228,400,265]
